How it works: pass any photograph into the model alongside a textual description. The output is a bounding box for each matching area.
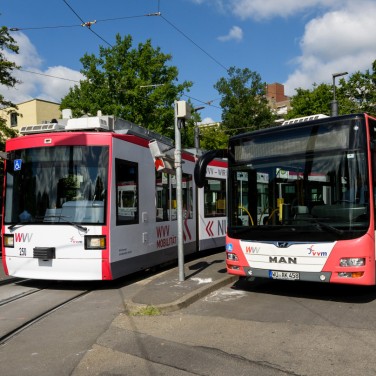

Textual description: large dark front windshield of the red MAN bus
[228,117,370,241]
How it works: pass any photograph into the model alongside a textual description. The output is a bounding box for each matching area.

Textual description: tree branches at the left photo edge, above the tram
[0,26,19,146]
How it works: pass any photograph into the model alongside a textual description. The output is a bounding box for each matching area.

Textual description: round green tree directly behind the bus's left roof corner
[214,67,274,136]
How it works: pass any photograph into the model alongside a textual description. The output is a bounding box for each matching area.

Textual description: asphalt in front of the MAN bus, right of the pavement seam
[81,280,376,376]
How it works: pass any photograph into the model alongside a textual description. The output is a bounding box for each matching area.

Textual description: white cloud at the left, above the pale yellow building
[0,33,83,104]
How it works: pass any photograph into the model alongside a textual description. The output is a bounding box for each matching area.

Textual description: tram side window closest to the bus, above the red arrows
[204,179,226,217]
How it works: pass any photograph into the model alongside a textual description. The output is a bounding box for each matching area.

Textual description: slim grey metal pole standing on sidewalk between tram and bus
[174,101,185,282]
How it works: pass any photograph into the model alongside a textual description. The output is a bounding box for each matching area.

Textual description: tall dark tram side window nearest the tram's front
[115,159,139,225]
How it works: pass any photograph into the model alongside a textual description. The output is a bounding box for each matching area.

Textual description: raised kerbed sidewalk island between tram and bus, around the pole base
[125,252,238,314]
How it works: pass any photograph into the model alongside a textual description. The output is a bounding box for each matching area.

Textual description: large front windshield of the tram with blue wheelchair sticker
[4,146,109,225]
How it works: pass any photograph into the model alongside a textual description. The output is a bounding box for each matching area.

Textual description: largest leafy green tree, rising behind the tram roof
[60,34,192,137]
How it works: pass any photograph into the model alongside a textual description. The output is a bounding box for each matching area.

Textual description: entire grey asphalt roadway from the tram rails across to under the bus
[0,270,376,376]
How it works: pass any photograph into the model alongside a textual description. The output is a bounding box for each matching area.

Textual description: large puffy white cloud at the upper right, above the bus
[284,1,376,95]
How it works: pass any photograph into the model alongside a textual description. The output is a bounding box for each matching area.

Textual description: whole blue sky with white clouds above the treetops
[0,0,376,122]
